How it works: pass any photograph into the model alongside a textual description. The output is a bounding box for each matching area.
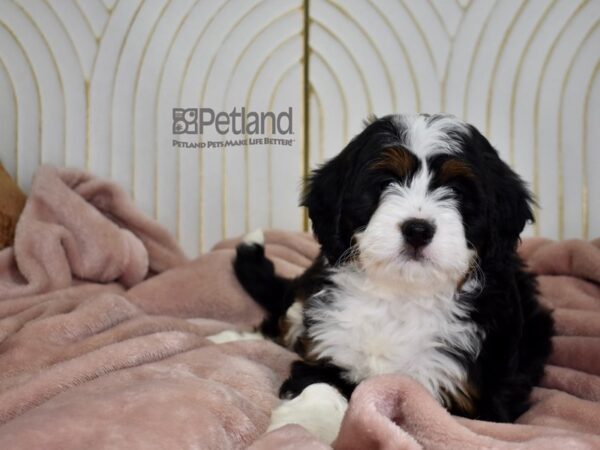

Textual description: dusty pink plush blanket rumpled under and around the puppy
[0,167,600,449]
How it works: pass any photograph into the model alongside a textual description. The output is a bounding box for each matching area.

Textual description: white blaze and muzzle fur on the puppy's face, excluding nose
[356,116,474,293]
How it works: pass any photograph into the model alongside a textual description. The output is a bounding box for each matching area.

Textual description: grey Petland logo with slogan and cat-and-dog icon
[173,107,294,148]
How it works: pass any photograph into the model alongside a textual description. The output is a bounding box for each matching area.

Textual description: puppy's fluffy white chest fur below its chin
[308,272,480,398]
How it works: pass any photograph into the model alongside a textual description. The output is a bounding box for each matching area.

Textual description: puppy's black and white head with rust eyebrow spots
[303,115,533,287]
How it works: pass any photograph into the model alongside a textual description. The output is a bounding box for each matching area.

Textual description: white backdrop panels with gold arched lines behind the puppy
[0,0,600,256]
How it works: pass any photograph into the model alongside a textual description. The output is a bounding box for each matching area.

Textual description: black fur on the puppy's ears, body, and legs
[235,116,553,422]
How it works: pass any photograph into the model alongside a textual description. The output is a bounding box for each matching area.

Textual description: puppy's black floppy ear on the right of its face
[474,130,534,257]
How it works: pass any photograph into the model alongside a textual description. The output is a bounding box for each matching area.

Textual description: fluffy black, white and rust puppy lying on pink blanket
[234,114,553,422]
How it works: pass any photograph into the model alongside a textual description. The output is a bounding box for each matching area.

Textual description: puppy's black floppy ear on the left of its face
[301,148,350,264]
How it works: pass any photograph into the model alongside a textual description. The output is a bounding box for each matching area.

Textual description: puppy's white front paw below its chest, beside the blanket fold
[267,380,348,444]
